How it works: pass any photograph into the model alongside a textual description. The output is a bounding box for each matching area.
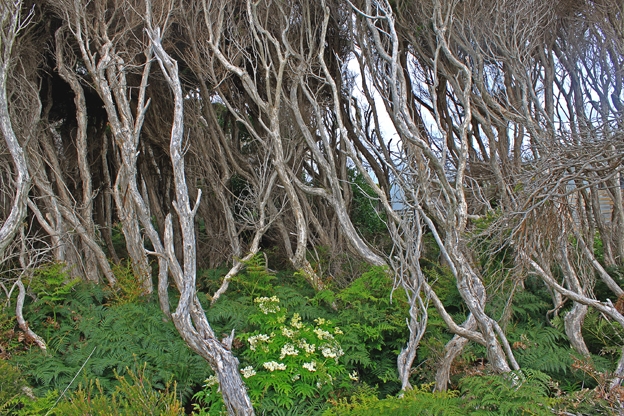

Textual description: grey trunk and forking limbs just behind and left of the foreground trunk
[61,0,155,294]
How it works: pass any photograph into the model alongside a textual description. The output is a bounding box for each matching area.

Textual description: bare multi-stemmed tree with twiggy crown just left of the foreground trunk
[52,1,164,293]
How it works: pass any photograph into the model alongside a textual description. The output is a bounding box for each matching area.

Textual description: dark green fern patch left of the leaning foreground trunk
[15,283,209,400]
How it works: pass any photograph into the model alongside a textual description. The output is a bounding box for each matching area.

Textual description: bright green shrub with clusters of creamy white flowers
[194,296,357,411]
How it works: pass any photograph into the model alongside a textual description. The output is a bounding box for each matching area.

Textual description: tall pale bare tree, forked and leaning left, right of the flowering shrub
[348,1,518,386]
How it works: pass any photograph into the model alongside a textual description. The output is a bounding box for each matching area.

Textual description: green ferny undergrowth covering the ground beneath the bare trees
[0,255,622,416]
